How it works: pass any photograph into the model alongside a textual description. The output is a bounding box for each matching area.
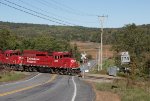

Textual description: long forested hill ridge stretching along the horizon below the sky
[0,21,150,44]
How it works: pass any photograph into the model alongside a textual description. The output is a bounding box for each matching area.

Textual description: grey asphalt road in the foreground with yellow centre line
[0,74,94,101]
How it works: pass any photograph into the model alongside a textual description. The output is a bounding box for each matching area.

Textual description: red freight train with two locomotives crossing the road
[0,50,80,74]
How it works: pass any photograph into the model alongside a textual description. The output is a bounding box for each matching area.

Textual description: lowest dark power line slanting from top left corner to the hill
[0,1,68,26]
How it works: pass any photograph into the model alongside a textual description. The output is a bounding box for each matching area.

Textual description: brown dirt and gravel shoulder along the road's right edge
[83,74,121,101]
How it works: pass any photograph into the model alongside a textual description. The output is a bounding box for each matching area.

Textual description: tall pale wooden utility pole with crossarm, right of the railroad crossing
[98,15,108,70]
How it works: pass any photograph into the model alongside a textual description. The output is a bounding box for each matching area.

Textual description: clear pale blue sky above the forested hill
[0,0,150,28]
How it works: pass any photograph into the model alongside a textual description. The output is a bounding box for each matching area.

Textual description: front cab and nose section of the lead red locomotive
[52,52,80,74]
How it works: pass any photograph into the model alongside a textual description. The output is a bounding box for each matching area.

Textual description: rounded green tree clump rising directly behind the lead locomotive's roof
[33,34,71,52]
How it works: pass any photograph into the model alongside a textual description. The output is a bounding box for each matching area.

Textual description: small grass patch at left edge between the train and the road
[0,71,25,82]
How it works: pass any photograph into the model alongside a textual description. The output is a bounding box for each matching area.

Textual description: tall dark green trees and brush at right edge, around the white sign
[112,24,150,80]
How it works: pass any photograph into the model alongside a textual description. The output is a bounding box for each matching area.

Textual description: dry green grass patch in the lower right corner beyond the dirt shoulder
[95,80,150,101]
